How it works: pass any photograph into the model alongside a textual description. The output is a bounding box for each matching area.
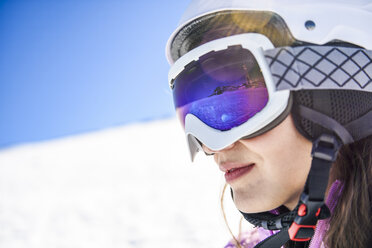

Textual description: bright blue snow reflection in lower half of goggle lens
[177,87,268,131]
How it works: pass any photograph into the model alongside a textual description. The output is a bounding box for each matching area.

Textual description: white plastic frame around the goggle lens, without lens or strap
[168,33,290,160]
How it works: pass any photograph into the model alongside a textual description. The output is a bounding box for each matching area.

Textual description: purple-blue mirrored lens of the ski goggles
[173,46,269,131]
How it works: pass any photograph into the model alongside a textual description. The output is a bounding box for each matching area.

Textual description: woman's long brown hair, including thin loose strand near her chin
[221,136,372,248]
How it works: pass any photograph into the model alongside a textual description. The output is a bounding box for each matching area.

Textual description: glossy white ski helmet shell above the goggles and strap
[166,0,372,64]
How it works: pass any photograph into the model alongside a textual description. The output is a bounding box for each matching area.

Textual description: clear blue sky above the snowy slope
[0,0,189,148]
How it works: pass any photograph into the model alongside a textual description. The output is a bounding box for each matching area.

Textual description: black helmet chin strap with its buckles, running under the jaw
[238,134,341,248]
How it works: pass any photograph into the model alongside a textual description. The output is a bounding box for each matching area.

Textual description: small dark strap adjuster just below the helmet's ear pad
[311,134,341,162]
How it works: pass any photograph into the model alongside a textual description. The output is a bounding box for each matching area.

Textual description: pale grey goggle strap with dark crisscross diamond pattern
[264,46,372,92]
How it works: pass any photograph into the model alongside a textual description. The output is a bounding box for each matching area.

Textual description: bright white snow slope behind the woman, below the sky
[0,119,251,248]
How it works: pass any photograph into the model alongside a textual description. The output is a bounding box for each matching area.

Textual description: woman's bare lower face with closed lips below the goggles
[203,115,312,213]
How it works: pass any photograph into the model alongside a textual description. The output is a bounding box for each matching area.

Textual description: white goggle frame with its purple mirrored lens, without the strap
[169,34,290,159]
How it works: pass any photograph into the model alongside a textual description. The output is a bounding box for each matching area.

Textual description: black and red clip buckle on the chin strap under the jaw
[288,193,329,242]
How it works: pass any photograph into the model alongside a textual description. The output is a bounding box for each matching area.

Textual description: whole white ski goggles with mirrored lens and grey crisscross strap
[168,33,372,160]
